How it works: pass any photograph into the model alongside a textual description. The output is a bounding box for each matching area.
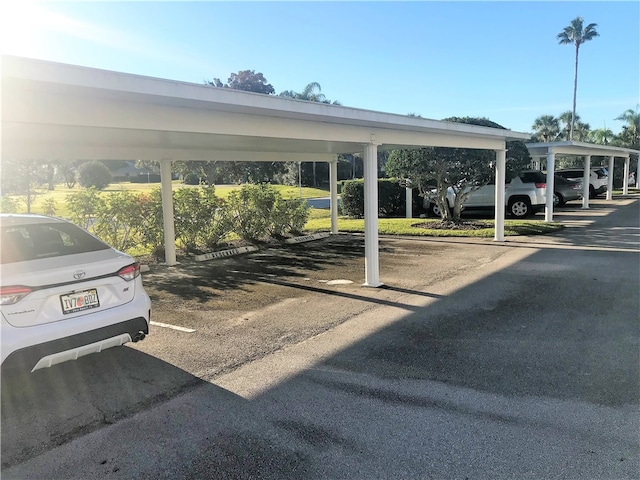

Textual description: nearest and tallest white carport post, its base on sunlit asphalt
[363,143,382,287]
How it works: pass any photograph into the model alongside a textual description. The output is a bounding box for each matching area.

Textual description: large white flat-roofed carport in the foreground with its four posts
[1,55,530,287]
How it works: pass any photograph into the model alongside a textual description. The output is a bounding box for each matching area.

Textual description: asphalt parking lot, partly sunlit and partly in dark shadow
[2,196,640,479]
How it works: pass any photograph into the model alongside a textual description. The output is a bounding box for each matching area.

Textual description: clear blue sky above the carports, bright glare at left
[0,0,640,133]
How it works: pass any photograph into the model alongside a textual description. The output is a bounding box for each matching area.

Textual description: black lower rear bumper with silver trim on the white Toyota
[2,317,149,372]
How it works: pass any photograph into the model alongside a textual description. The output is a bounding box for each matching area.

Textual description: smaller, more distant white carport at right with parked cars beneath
[526,141,640,222]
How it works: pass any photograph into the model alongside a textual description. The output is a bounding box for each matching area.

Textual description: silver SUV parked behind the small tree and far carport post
[424,170,547,218]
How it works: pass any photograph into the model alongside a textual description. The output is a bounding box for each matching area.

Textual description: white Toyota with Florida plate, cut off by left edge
[0,214,151,372]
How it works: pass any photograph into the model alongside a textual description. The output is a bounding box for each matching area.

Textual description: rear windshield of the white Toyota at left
[0,223,111,264]
